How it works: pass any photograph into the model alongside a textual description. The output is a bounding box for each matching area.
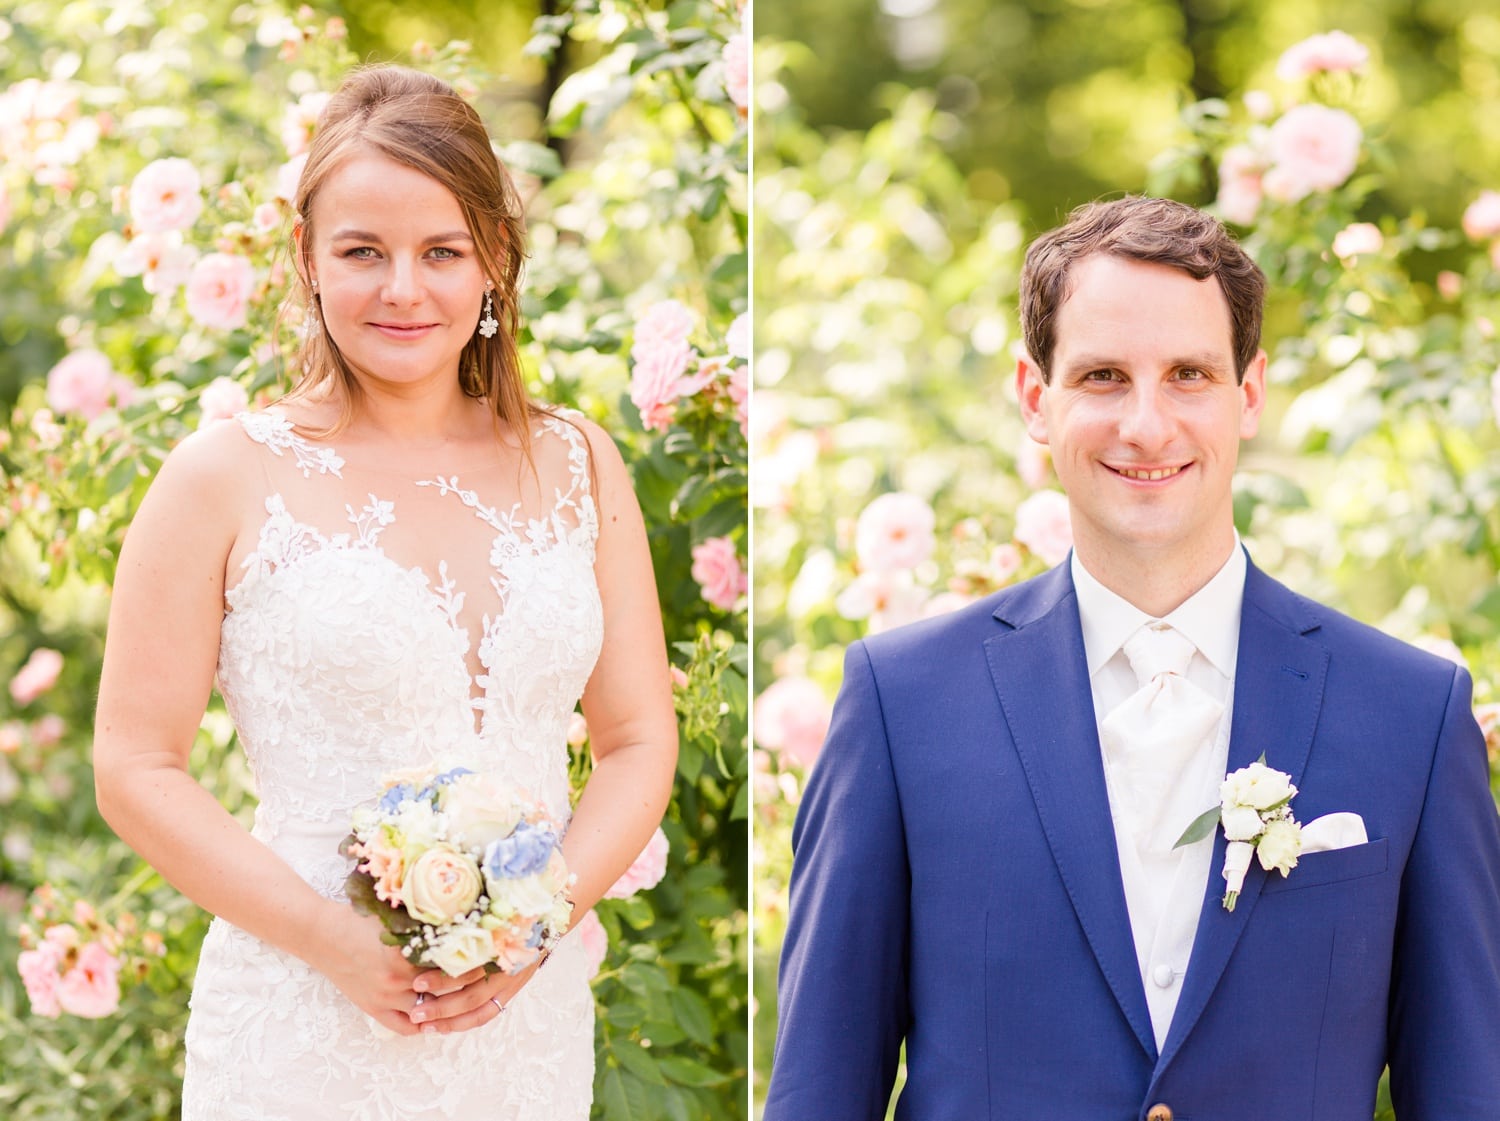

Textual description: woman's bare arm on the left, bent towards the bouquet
[95,425,429,1032]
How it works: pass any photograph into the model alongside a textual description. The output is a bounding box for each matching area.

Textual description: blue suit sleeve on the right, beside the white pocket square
[1388,669,1500,1121]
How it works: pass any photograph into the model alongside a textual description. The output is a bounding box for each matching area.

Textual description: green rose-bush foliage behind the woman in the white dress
[0,0,749,1119]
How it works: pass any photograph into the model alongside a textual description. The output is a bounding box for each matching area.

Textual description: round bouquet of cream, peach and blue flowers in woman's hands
[339,767,573,977]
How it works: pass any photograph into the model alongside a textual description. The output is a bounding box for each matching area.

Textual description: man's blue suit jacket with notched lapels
[765,564,1500,1121]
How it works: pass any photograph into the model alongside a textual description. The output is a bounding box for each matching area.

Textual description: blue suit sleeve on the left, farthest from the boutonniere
[764,642,911,1121]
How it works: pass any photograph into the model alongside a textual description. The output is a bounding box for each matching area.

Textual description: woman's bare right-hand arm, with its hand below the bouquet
[417,422,677,1032]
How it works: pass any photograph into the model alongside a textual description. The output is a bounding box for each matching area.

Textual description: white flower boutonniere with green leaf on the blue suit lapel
[1173,755,1302,911]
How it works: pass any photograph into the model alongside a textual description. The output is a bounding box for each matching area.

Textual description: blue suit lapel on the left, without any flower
[984,564,1157,1056]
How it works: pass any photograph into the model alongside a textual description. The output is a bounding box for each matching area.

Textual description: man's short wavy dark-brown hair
[1020,197,1266,381]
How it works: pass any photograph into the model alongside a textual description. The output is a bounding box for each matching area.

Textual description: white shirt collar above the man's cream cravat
[1070,531,1247,680]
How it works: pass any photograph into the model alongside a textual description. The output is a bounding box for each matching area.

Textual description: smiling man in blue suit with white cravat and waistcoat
[765,198,1500,1121]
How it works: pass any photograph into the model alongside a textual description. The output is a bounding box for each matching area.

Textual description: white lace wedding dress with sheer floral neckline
[183,410,603,1121]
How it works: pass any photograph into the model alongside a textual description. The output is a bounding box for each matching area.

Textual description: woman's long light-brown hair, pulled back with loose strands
[288,66,540,447]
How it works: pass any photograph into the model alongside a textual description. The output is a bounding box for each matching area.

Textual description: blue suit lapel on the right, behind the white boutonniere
[1157,564,1328,1074]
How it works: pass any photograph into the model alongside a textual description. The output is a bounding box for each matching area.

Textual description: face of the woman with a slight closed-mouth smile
[309,155,485,387]
